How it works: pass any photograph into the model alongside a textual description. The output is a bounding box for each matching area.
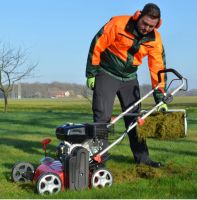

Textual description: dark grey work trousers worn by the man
[92,71,149,163]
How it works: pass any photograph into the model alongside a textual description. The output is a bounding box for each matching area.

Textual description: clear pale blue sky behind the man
[0,0,197,89]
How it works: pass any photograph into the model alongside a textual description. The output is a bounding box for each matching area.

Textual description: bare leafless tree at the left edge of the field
[0,45,37,112]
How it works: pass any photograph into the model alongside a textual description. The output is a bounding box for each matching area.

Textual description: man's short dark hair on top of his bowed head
[141,3,161,19]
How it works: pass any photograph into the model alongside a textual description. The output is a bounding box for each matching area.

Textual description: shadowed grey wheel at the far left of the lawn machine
[11,162,34,182]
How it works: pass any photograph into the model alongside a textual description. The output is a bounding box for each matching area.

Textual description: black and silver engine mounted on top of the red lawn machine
[56,123,112,160]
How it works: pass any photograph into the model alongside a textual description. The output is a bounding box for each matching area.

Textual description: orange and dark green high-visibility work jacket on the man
[86,16,165,94]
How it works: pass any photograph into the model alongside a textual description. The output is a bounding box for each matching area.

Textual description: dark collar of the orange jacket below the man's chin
[125,17,155,42]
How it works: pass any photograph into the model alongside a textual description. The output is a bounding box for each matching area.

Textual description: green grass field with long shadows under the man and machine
[0,97,197,199]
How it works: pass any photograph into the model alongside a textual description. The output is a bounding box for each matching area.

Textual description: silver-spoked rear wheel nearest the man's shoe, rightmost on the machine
[91,168,113,188]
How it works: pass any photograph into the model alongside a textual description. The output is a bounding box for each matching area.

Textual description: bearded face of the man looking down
[137,15,159,35]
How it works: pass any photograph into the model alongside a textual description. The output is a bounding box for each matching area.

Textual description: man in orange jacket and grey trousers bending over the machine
[86,3,167,167]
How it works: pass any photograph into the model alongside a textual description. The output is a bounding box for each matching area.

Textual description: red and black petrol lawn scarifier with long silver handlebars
[12,69,187,194]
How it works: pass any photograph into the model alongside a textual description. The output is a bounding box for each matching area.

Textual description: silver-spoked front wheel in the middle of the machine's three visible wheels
[36,172,62,194]
